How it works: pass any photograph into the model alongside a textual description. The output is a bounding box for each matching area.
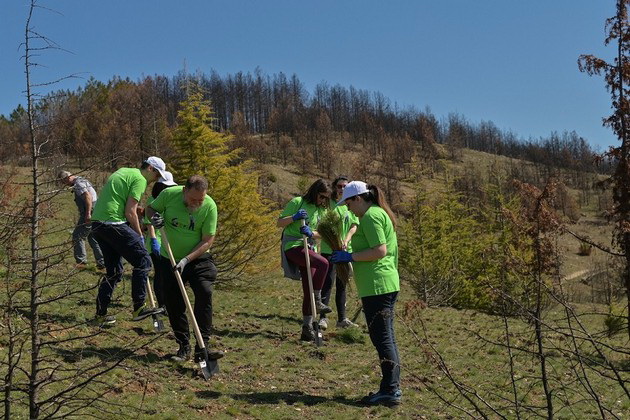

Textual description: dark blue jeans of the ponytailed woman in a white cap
[361,292,400,393]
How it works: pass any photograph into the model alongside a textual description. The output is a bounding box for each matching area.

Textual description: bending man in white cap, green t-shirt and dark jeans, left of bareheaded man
[92,156,166,327]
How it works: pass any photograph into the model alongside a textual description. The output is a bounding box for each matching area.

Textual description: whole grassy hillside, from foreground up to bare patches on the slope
[0,152,630,419]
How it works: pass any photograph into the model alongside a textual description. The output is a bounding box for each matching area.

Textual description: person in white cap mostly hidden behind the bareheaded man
[142,171,177,308]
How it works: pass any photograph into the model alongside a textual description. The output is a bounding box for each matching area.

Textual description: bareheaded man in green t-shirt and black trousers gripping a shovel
[146,175,223,362]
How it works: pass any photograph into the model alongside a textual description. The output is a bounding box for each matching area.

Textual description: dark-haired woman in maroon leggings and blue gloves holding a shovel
[277,179,332,341]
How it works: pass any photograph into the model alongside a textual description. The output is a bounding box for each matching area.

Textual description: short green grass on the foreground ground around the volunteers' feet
[2,260,630,419]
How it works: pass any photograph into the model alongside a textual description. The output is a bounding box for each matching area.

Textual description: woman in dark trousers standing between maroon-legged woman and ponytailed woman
[319,175,359,330]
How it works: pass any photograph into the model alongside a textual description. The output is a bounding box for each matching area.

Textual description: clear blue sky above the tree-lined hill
[0,0,617,150]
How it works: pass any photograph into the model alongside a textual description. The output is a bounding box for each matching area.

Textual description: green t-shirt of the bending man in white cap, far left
[92,168,147,222]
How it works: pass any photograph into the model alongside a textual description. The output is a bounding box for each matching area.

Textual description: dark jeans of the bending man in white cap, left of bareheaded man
[92,222,151,315]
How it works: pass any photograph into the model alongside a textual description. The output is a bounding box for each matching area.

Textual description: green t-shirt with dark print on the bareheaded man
[151,185,217,261]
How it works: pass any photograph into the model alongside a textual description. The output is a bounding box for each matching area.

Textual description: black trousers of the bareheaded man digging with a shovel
[160,254,217,345]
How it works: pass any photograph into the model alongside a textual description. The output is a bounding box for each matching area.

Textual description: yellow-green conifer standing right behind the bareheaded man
[171,88,277,280]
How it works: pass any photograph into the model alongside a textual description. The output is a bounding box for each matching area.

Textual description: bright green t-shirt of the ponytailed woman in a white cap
[352,205,400,297]
